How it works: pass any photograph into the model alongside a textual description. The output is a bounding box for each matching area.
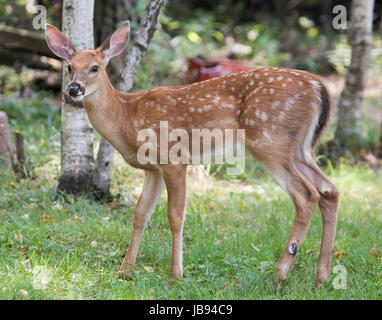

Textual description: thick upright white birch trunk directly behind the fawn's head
[58,0,94,194]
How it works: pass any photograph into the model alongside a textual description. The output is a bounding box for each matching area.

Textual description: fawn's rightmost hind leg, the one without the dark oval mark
[296,160,339,286]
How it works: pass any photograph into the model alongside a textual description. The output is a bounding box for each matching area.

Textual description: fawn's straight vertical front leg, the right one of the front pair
[162,165,187,278]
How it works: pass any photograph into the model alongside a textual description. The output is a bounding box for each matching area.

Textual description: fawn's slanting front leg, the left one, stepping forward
[118,170,163,279]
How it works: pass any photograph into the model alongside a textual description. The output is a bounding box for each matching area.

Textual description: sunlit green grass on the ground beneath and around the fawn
[0,94,382,299]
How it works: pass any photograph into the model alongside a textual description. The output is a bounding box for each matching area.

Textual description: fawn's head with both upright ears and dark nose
[45,21,130,101]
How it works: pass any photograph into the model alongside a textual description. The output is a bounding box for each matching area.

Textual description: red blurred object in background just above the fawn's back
[186,57,254,83]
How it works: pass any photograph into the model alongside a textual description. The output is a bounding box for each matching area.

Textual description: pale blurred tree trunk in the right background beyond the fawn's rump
[335,0,374,152]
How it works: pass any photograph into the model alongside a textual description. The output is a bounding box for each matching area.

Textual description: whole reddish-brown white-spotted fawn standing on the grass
[46,21,339,285]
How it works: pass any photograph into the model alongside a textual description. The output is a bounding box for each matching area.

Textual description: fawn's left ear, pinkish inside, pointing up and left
[45,24,76,61]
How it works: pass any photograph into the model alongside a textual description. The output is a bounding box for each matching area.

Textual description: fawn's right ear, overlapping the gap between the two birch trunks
[98,20,130,63]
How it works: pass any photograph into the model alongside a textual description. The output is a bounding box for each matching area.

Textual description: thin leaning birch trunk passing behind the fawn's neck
[93,0,163,198]
